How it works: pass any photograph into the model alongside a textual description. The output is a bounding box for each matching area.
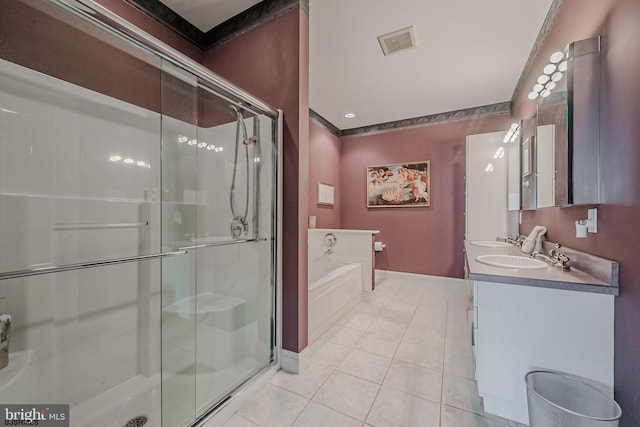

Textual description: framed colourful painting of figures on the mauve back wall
[367,160,431,208]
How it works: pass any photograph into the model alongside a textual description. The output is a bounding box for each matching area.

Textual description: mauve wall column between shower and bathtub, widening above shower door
[204,8,309,352]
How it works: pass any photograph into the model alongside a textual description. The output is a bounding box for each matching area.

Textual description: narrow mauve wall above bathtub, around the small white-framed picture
[309,120,342,228]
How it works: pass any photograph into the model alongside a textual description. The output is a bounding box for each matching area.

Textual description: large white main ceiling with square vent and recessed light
[309,0,552,129]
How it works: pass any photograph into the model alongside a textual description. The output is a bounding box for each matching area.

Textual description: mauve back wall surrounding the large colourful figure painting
[340,115,511,277]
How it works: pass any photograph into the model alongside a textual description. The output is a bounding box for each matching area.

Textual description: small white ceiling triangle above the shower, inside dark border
[160,0,260,33]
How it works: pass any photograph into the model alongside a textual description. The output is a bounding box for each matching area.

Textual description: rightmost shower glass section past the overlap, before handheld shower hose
[194,82,275,415]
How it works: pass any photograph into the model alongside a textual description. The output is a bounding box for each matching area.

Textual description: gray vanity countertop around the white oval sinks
[464,240,618,295]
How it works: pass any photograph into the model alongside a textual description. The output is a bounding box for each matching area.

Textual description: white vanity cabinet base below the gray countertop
[473,280,614,425]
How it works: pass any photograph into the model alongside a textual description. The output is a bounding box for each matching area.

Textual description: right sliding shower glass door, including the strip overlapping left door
[161,67,275,426]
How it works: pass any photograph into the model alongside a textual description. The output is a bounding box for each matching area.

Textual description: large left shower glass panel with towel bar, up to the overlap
[0,0,168,427]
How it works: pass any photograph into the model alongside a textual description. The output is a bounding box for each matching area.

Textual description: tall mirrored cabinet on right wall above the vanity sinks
[521,37,600,208]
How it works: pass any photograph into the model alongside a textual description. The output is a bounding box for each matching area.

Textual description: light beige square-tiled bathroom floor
[205,273,521,427]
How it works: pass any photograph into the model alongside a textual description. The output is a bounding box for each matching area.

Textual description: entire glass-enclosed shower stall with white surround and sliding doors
[0,0,280,427]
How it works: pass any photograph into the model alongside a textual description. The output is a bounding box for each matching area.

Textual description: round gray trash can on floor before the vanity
[524,370,622,427]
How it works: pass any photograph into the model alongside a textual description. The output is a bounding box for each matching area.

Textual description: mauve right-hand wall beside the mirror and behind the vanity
[520,0,640,427]
